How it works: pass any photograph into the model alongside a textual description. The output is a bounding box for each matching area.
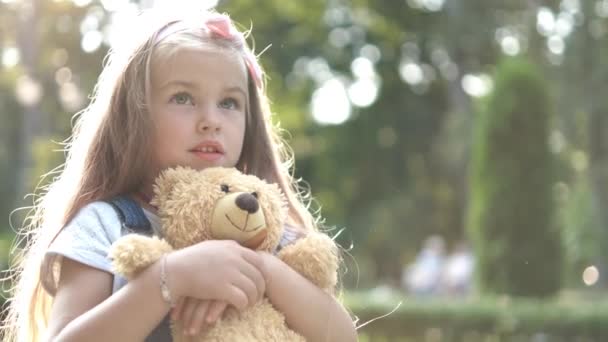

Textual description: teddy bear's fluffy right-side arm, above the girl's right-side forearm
[278,232,339,293]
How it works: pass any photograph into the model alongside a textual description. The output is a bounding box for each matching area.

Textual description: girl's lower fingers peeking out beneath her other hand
[171,297,228,336]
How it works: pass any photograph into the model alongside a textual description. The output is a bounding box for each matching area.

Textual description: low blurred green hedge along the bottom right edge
[346,296,608,342]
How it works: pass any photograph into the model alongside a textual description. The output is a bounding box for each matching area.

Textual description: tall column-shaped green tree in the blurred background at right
[468,59,562,296]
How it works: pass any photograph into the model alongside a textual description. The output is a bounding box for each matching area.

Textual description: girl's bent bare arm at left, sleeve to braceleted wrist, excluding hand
[47,258,169,341]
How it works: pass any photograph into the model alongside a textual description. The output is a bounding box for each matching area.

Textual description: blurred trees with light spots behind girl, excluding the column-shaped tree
[0,0,608,302]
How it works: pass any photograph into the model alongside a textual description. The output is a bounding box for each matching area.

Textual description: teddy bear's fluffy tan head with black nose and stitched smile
[152,167,287,251]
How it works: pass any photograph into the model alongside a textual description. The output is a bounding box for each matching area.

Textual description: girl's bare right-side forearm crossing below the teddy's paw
[261,253,357,342]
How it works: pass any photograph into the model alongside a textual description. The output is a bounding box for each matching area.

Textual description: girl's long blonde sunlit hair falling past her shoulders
[2,10,317,342]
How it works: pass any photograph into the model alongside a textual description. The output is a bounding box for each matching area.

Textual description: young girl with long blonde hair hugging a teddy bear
[3,6,356,341]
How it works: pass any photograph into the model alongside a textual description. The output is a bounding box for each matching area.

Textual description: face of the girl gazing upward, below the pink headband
[151,49,249,176]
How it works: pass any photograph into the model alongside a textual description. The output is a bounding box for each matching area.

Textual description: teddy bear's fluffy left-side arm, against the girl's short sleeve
[109,234,173,279]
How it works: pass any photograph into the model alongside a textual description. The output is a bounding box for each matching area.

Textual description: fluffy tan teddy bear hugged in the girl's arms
[110,167,339,342]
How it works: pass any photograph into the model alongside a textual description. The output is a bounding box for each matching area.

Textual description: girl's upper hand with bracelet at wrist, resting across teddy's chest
[166,240,266,311]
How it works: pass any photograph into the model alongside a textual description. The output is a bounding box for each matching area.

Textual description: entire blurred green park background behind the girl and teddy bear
[0,0,608,341]
